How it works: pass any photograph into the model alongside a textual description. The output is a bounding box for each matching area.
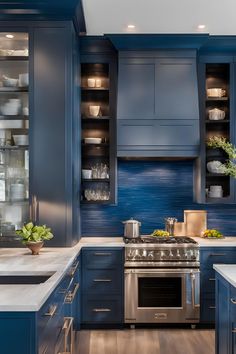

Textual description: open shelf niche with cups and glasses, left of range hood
[81,63,115,204]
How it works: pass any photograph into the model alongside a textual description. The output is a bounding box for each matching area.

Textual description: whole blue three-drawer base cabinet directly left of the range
[81,247,124,327]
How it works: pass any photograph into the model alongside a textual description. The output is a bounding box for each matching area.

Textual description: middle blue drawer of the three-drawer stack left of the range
[83,269,123,294]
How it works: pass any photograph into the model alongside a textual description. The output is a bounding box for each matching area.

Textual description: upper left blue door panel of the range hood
[117,59,155,119]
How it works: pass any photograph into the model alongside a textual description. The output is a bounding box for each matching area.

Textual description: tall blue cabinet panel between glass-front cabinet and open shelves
[0,21,80,247]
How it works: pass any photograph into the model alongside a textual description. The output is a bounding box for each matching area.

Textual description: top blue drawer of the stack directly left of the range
[82,248,124,271]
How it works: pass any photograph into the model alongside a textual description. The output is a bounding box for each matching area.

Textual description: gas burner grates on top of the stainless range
[124,236,197,244]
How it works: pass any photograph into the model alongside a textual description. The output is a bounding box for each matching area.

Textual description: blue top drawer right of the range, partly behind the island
[200,248,236,269]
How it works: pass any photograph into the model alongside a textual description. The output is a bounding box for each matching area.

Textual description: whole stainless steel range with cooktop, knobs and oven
[125,236,200,324]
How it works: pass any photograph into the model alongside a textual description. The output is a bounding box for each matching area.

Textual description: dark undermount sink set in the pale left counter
[0,272,55,285]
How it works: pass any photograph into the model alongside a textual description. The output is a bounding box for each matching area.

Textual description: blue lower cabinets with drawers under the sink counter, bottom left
[0,253,80,354]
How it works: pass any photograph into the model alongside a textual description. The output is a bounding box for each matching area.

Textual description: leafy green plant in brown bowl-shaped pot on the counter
[16,222,53,255]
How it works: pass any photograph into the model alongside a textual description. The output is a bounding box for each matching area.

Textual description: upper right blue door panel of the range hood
[155,58,199,119]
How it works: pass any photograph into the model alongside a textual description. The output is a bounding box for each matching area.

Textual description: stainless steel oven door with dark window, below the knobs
[125,268,200,323]
